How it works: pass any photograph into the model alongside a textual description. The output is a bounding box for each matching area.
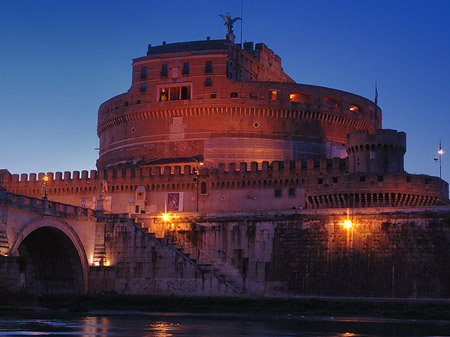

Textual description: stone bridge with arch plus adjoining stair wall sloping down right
[0,191,239,295]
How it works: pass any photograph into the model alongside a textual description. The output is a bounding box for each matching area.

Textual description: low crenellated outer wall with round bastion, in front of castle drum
[2,158,448,213]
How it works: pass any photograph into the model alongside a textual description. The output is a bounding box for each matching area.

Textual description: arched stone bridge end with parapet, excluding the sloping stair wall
[0,192,98,293]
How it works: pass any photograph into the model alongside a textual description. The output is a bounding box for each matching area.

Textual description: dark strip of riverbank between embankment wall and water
[0,293,450,321]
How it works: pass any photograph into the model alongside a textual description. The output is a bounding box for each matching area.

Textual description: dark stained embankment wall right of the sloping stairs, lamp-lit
[163,210,450,298]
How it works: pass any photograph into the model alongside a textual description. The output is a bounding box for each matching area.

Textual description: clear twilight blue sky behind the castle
[0,0,450,181]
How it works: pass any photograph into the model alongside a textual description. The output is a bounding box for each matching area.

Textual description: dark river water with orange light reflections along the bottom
[0,312,450,337]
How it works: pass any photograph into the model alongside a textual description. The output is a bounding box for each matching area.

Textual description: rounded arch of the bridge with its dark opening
[9,216,89,295]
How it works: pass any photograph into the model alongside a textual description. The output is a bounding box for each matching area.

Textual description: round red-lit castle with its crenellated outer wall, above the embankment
[1,34,448,215]
